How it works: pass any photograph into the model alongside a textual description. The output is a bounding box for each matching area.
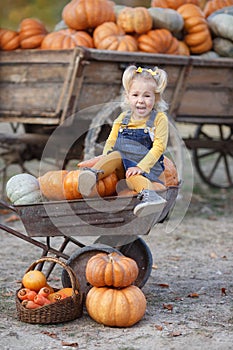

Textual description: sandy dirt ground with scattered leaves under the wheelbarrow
[0,135,233,350]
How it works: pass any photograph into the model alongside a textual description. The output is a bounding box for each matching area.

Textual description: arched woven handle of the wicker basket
[25,256,80,295]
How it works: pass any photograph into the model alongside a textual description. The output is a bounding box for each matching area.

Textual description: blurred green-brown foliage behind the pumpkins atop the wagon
[0,0,150,31]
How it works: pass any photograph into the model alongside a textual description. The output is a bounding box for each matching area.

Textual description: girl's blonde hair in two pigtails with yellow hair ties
[122,66,168,112]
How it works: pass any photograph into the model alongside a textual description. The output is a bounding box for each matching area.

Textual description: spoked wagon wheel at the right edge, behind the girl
[193,124,233,188]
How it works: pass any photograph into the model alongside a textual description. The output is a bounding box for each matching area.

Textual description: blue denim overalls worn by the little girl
[113,110,164,182]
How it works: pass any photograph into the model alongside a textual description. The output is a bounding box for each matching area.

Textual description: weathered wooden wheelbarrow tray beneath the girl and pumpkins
[9,186,178,237]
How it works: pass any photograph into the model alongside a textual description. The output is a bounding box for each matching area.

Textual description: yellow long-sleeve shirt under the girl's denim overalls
[103,112,168,173]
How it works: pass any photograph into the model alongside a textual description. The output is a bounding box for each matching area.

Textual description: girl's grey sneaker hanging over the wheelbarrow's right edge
[134,190,167,217]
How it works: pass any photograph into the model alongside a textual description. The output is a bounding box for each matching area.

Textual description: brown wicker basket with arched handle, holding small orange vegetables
[16,257,83,324]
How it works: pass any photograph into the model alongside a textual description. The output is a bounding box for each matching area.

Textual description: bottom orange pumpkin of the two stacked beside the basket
[86,285,146,327]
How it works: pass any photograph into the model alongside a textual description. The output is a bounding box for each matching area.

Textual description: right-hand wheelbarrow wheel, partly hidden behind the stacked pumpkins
[95,236,153,288]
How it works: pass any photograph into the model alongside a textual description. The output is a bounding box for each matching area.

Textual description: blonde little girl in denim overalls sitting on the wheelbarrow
[78,66,168,216]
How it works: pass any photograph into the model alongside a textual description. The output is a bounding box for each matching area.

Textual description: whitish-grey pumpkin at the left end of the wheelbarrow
[6,173,42,205]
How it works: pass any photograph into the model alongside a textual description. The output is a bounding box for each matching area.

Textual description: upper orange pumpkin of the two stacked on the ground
[86,252,139,288]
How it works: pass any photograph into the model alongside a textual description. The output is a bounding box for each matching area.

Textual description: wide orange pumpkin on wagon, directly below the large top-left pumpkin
[41,28,94,50]
